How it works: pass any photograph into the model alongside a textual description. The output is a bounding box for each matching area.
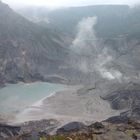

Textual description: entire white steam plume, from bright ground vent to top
[71,17,122,81]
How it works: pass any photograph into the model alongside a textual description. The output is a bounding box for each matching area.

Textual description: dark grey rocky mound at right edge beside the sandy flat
[104,82,140,120]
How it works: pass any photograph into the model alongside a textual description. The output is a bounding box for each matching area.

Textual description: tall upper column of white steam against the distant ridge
[71,17,97,55]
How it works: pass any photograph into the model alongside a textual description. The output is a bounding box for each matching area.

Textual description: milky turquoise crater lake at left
[0,82,66,120]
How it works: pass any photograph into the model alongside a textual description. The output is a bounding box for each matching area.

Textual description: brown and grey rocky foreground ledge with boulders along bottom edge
[4,121,140,140]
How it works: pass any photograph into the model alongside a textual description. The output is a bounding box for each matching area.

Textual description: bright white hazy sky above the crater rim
[2,0,140,7]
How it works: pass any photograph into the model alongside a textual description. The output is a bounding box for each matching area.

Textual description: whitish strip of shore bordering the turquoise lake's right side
[14,85,82,124]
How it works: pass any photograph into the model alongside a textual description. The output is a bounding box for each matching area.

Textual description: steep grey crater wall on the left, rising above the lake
[0,2,71,83]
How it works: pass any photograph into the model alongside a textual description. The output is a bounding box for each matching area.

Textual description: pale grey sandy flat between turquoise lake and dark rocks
[16,86,120,123]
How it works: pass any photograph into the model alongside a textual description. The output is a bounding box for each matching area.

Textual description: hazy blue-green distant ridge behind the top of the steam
[17,5,140,38]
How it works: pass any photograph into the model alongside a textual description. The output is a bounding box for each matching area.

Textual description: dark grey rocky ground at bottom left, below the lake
[0,119,60,140]
